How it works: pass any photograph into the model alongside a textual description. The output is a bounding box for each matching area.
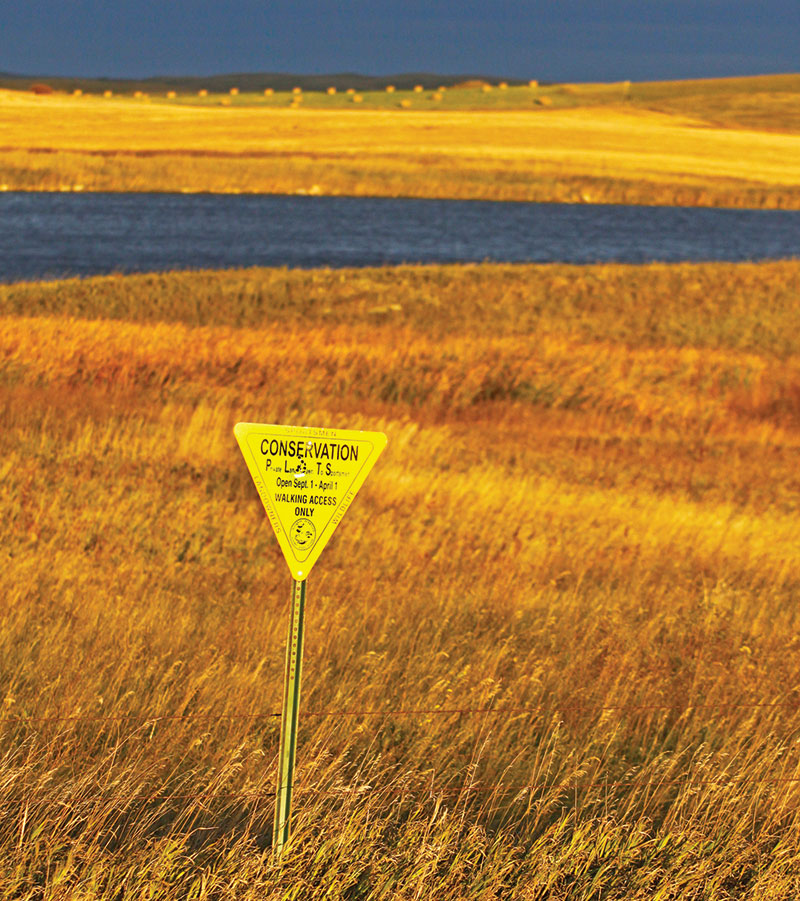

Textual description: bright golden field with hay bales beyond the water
[0,75,800,209]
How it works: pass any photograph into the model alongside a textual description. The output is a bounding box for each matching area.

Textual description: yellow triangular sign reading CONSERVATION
[233,422,386,582]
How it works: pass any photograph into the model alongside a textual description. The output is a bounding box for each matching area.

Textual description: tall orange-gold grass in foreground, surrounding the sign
[0,262,800,901]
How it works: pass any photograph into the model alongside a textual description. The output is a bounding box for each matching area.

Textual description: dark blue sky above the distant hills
[6,0,800,81]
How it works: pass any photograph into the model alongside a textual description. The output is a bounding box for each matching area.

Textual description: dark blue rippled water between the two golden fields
[0,192,800,282]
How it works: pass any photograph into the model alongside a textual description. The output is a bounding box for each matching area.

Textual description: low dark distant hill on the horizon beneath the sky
[0,72,527,94]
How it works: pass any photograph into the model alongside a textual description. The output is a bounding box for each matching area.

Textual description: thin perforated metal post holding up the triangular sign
[272,579,306,857]
